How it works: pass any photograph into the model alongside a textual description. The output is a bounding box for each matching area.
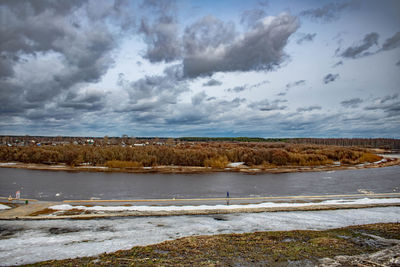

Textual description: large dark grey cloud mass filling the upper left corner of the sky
[0,1,132,118]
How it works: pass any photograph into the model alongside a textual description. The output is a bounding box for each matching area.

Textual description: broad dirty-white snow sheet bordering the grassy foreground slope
[0,207,400,265]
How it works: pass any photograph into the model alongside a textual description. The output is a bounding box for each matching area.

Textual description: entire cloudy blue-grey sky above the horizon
[0,0,400,138]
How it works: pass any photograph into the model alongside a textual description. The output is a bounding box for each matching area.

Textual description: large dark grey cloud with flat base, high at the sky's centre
[183,13,299,77]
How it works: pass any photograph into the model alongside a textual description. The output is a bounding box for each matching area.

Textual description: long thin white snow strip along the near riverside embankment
[49,198,400,214]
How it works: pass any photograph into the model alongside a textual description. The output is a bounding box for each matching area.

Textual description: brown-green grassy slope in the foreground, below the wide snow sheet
[23,223,400,266]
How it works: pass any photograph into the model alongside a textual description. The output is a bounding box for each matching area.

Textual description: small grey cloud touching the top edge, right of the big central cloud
[300,2,354,22]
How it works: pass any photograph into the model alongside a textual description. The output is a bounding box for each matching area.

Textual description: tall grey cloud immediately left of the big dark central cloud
[139,0,182,62]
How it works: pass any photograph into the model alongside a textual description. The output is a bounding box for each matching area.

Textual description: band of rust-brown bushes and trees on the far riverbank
[0,142,380,167]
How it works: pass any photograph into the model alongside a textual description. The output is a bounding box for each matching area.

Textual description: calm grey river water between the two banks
[0,166,400,200]
